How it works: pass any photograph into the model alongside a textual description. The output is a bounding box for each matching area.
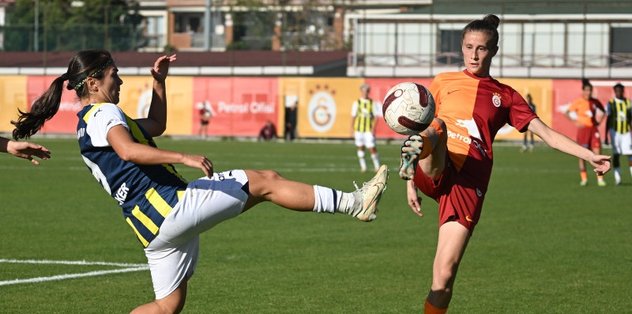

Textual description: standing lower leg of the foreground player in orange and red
[427,221,470,308]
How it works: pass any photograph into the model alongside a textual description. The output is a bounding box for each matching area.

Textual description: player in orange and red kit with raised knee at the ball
[400,15,610,313]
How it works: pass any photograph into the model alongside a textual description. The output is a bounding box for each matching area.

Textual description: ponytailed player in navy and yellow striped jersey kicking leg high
[13,50,388,313]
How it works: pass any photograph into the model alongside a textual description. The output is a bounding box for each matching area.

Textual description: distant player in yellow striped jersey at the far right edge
[606,83,632,185]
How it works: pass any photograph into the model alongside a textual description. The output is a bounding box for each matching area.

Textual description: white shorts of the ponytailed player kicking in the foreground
[145,170,248,300]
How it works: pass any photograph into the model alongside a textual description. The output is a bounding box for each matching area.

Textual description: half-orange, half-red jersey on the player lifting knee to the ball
[429,70,537,190]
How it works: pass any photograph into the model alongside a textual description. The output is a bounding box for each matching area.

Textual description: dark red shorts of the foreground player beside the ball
[414,158,487,232]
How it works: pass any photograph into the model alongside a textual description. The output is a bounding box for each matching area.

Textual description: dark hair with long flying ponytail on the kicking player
[11,50,113,140]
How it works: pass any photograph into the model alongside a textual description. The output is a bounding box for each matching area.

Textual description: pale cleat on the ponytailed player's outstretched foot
[349,165,388,222]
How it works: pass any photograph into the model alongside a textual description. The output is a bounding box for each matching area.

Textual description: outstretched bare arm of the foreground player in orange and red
[528,118,610,175]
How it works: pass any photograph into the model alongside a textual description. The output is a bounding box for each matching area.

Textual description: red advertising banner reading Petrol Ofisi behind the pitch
[189,77,282,136]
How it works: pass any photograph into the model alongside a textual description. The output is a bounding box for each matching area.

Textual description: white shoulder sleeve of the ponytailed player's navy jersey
[86,104,129,147]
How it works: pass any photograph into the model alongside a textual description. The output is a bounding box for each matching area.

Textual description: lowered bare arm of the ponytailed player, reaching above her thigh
[107,125,213,176]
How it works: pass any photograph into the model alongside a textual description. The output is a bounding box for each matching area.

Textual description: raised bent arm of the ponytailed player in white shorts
[136,55,176,137]
